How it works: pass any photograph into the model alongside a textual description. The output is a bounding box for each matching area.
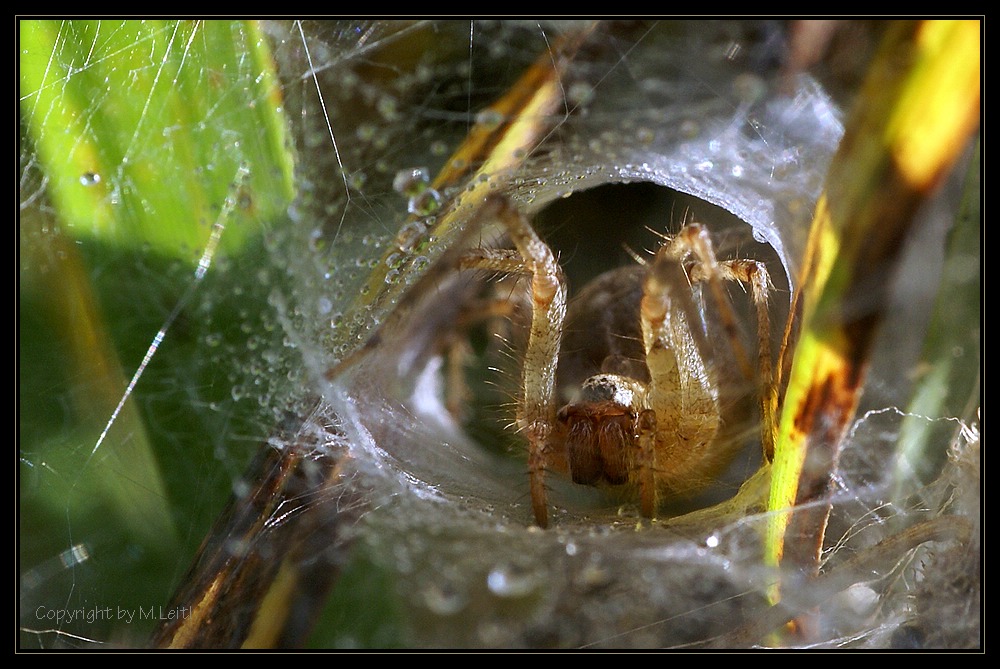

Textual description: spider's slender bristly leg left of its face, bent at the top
[459,197,566,527]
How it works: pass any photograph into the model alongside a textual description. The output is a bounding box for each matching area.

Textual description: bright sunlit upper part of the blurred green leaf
[20,21,292,254]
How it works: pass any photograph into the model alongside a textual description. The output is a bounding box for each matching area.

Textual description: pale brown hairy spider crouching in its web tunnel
[459,196,777,528]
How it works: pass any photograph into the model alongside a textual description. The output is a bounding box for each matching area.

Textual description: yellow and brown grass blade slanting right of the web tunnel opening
[766,21,981,596]
